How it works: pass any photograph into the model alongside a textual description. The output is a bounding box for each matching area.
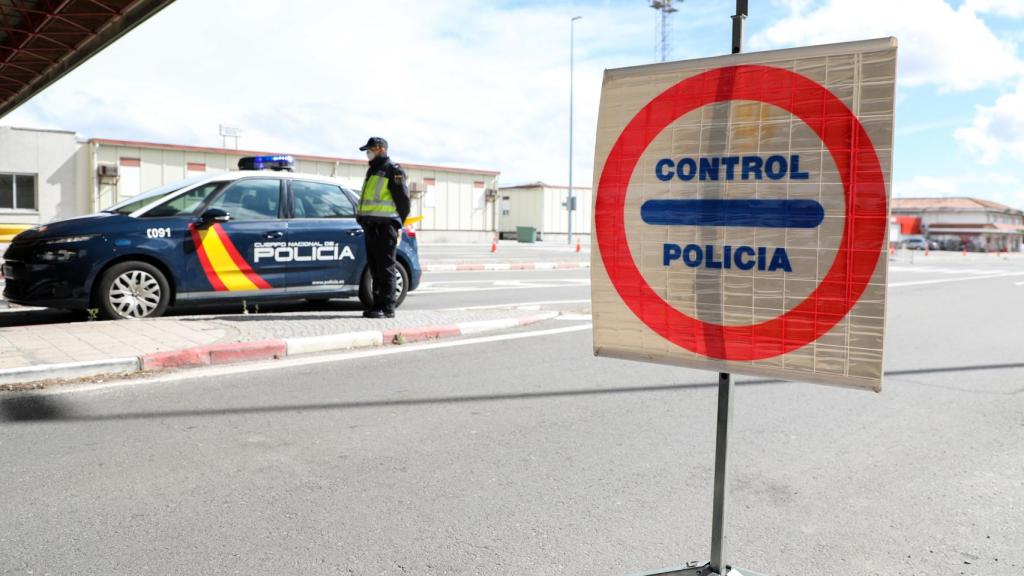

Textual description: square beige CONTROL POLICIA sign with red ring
[592,38,896,390]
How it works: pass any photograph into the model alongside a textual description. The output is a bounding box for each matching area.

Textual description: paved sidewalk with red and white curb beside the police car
[0,308,558,385]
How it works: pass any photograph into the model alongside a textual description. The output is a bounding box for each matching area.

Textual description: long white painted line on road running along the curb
[37,324,593,395]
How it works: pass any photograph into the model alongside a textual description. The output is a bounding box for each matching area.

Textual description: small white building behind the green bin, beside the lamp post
[498,182,594,243]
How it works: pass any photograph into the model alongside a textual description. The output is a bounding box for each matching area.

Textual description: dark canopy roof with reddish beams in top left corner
[0,0,174,118]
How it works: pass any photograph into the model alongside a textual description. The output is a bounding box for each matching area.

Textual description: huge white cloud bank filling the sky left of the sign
[4,0,652,184]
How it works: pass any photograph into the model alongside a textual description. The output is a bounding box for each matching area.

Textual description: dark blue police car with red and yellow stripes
[3,156,421,319]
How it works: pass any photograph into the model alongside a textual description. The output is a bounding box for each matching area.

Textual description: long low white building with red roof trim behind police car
[0,126,499,242]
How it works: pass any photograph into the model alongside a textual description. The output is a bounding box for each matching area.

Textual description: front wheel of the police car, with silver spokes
[96,261,171,320]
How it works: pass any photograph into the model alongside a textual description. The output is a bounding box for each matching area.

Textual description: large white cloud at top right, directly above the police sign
[751,0,1024,90]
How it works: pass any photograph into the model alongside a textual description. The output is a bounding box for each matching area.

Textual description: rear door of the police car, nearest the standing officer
[286,179,366,293]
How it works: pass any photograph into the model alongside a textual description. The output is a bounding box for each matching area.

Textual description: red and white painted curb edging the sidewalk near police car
[0,311,559,384]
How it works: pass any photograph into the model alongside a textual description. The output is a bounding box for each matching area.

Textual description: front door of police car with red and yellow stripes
[187,177,288,299]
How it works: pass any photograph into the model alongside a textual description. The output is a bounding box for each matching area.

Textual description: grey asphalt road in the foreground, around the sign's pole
[0,257,1024,576]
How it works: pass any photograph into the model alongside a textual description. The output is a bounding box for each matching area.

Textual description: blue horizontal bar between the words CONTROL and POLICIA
[640,199,825,228]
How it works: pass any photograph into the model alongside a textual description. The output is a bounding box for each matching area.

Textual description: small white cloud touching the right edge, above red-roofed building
[954,82,1024,164]
